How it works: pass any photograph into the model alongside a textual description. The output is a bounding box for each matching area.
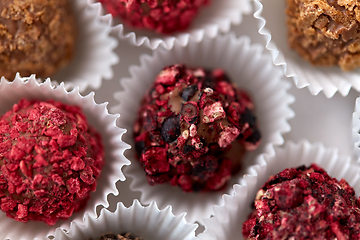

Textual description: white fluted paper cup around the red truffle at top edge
[88,0,252,50]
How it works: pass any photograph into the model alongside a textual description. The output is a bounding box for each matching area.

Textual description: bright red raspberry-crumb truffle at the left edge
[0,99,104,225]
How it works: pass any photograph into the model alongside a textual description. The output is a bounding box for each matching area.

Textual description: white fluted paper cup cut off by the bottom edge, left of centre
[55,200,198,240]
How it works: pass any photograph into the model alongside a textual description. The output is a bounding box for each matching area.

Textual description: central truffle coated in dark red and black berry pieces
[134,65,260,192]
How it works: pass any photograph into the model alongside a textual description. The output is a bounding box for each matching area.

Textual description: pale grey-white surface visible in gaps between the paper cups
[87,3,359,225]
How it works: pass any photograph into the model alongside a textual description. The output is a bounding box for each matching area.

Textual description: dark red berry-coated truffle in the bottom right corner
[243,164,360,240]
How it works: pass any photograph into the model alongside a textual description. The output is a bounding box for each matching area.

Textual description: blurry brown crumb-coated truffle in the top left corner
[0,0,76,80]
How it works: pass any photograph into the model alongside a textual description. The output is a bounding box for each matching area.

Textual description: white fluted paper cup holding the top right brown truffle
[254,0,360,98]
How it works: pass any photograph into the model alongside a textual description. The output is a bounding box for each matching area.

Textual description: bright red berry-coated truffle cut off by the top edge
[99,0,209,33]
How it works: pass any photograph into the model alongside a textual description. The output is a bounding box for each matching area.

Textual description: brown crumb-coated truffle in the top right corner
[286,0,360,71]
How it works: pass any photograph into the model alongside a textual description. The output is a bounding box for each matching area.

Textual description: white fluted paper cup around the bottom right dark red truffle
[198,140,360,240]
